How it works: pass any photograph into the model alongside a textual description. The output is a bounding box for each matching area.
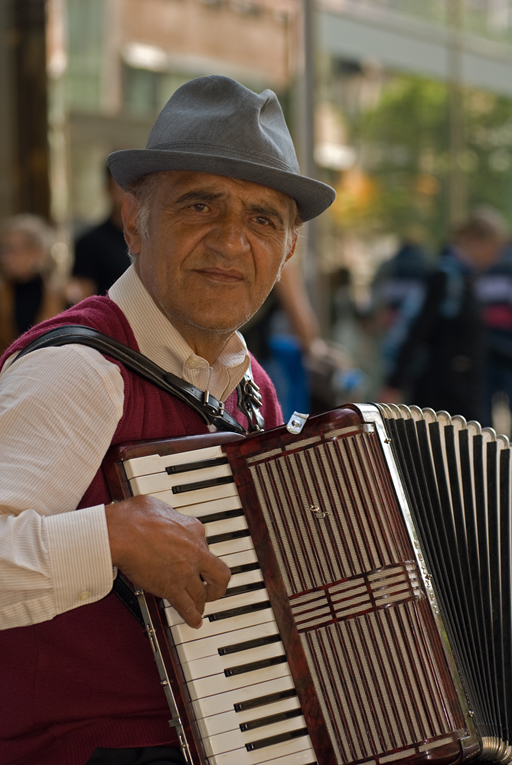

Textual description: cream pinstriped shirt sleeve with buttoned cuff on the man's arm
[0,345,124,629]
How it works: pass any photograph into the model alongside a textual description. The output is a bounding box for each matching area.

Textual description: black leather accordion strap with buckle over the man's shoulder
[15,324,264,434]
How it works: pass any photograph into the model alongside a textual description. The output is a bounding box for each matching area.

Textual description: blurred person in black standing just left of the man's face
[66,165,130,305]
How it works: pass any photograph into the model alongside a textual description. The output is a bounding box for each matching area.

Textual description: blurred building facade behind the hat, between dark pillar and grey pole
[48,0,298,234]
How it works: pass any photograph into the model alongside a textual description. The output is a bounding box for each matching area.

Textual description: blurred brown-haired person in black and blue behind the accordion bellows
[379,208,506,426]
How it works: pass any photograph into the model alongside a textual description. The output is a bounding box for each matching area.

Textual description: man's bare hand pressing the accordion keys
[105,496,231,628]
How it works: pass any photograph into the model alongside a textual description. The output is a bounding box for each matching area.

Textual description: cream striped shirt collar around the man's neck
[108,265,249,401]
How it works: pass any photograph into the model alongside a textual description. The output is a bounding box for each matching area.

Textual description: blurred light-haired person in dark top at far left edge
[0,214,64,353]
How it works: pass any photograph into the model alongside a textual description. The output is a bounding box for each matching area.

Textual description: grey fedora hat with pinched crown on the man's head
[108,75,336,221]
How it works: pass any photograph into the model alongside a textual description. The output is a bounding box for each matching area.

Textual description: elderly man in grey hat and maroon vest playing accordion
[0,77,334,765]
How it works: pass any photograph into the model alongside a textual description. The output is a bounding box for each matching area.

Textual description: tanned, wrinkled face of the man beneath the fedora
[123,171,296,355]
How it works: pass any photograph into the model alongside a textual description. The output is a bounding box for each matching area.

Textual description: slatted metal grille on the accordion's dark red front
[249,431,463,765]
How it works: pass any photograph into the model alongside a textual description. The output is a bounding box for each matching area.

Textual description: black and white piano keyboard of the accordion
[124,446,316,765]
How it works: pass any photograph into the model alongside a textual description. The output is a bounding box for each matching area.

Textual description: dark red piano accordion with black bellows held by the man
[104,404,512,765]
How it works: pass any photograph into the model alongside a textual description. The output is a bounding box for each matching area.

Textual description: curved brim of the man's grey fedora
[108,149,336,222]
